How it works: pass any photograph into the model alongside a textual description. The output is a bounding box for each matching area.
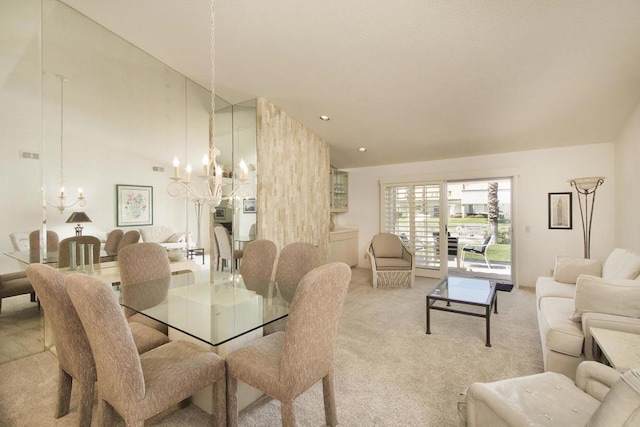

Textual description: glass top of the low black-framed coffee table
[429,276,496,305]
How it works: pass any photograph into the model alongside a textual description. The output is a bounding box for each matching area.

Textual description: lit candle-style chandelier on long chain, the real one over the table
[167,0,250,213]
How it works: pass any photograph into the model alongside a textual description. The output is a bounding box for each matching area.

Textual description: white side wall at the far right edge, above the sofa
[615,103,640,252]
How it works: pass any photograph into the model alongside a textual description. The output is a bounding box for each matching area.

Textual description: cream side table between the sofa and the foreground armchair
[589,328,640,372]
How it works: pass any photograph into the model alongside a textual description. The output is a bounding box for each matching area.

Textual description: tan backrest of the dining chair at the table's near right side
[280,262,351,395]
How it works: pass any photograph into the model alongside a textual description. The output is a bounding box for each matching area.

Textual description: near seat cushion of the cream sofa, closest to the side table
[538,297,584,357]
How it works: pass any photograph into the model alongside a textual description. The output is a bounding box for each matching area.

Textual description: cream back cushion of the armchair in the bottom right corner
[588,369,640,427]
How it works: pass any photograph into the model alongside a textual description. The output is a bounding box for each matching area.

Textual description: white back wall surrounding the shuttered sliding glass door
[335,143,615,286]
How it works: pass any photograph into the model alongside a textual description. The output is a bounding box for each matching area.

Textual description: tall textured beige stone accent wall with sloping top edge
[257,98,330,263]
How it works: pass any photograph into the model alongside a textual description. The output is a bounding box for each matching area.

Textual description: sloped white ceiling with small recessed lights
[58,0,640,168]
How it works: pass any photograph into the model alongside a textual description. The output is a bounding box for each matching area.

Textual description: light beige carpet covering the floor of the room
[0,269,542,427]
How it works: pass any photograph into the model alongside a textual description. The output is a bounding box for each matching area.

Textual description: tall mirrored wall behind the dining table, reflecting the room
[0,0,257,270]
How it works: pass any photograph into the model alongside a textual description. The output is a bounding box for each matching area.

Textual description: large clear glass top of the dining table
[118,270,290,346]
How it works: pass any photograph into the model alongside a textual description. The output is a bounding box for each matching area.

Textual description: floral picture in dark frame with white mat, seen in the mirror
[116,184,153,227]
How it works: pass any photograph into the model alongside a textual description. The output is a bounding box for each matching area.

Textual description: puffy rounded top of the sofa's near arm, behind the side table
[570,275,640,322]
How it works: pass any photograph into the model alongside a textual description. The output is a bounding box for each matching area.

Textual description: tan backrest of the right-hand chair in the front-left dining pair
[65,273,145,405]
